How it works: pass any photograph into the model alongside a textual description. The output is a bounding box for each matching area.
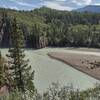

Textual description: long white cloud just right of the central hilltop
[43,0,72,11]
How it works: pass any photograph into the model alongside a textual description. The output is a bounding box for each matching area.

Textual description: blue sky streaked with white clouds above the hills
[0,0,100,10]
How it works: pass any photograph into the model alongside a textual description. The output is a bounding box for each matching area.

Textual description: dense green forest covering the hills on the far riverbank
[0,7,100,48]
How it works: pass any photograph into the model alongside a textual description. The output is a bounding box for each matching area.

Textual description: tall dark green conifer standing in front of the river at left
[7,18,34,92]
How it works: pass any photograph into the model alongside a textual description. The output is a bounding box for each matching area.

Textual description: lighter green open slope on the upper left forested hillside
[0,8,45,28]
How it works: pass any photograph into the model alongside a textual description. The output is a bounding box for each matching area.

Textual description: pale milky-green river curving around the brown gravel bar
[1,48,99,93]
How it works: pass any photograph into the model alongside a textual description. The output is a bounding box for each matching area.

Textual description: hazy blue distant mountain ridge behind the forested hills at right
[76,5,100,13]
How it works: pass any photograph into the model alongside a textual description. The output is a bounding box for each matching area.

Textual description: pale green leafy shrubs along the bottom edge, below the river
[0,83,100,100]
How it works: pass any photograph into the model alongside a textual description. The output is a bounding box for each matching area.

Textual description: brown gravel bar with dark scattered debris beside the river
[48,50,100,80]
